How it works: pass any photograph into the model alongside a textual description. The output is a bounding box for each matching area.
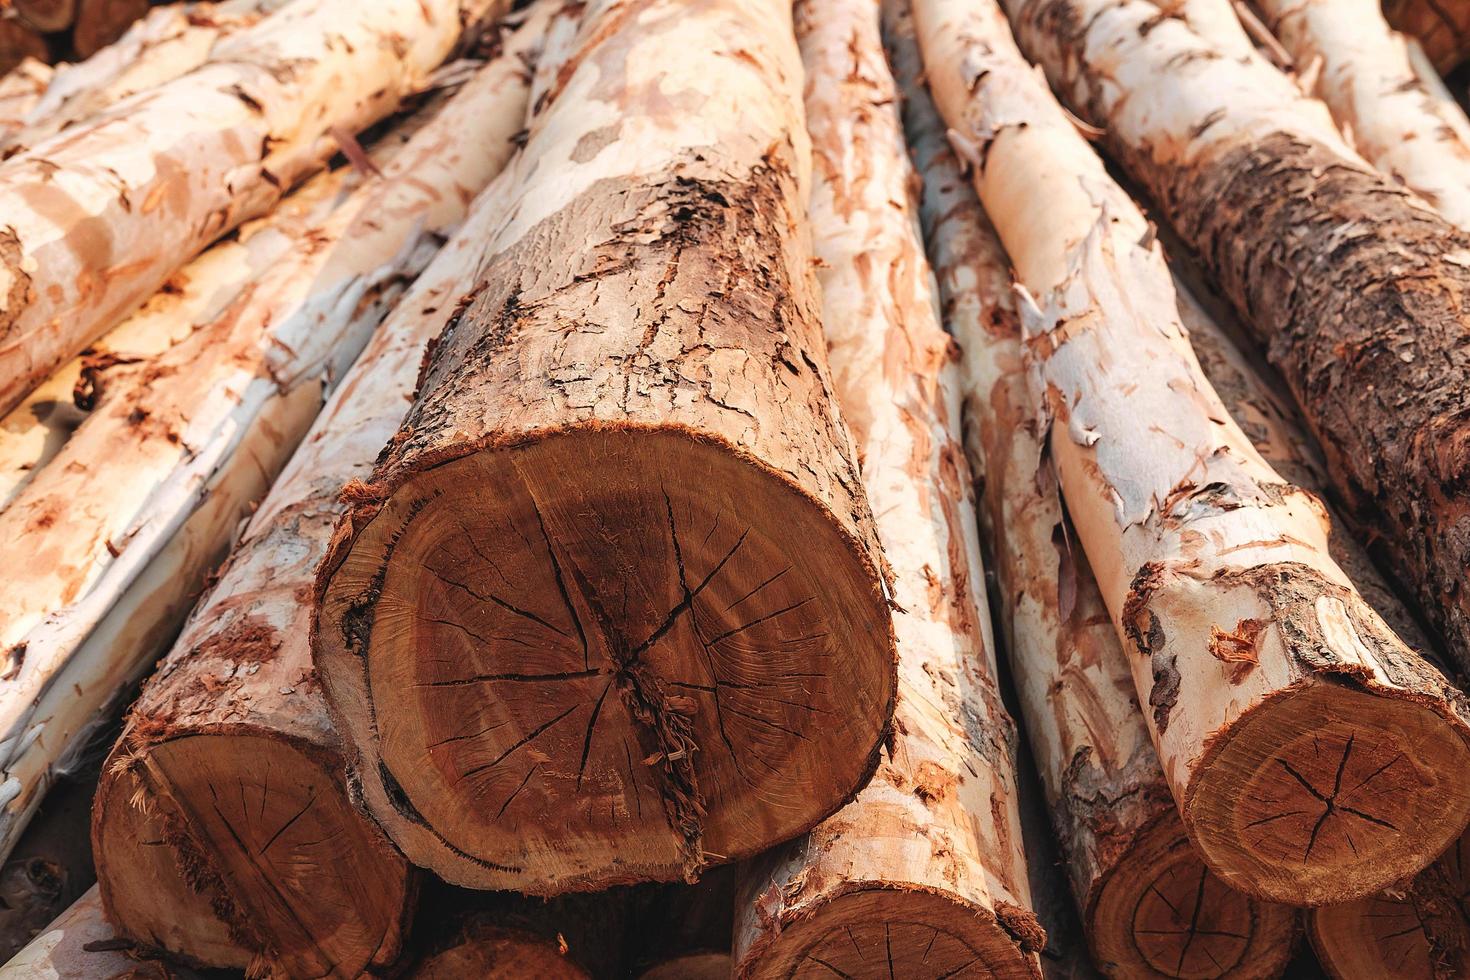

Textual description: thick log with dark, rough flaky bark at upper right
[1007,0,1470,681]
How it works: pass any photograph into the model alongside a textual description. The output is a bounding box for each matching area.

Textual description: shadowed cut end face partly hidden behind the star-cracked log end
[1085,810,1297,980]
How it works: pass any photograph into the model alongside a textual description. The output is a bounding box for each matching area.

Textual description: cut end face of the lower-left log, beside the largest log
[93,733,413,977]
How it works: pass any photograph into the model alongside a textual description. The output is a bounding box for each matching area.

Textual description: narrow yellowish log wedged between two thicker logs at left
[0,163,345,510]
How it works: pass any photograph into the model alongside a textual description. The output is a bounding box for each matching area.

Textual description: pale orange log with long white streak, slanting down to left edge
[0,13,540,863]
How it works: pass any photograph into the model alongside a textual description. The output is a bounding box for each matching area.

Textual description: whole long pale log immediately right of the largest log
[735,0,1045,979]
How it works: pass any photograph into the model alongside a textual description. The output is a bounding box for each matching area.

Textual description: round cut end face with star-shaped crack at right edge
[1183,677,1470,907]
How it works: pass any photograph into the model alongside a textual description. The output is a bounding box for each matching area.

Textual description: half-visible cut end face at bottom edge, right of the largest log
[738,886,1041,980]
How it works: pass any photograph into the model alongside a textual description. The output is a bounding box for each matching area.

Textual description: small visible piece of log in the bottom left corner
[0,889,197,980]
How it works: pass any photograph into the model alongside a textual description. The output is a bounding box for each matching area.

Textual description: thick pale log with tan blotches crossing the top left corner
[0,0,504,410]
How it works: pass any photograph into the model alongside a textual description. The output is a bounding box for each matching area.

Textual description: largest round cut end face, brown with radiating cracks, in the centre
[316,428,897,895]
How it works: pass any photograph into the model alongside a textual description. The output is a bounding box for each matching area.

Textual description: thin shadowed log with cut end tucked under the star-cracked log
[885,3,1295,977]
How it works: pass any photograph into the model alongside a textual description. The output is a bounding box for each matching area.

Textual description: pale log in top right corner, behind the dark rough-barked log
[1246,0,1470,229]
